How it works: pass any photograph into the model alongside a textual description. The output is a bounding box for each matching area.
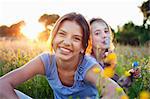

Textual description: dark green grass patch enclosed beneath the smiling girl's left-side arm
[17,75,53,99]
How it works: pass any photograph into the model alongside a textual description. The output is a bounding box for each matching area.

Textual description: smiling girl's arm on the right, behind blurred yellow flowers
[85,65,125,99]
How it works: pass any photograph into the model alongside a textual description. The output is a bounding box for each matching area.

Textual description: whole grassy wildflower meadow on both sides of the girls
[0,40,150,99]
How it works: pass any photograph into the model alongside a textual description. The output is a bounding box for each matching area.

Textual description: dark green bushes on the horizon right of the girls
[115,22,150,45]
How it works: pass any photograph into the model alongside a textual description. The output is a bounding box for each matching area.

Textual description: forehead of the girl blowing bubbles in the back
[91,21,108,30]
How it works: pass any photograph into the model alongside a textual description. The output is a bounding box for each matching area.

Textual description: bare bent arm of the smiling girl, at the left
[0,56,45,99]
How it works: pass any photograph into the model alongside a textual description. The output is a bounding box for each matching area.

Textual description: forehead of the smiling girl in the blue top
[58,20,83,35]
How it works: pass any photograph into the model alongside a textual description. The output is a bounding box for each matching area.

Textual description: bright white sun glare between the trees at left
[21,22,44,40]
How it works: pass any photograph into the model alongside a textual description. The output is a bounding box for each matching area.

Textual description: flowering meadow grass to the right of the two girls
[116,45,150,99]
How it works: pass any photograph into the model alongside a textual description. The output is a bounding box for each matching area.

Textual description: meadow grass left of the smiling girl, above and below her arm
[0,41,53,99]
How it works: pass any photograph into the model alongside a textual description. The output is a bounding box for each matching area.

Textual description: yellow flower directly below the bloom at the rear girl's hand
[103,67,115,78]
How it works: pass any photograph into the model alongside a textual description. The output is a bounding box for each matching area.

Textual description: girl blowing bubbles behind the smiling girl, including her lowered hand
[88,18,140,89]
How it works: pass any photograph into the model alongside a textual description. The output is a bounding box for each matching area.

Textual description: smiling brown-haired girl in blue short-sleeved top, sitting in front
[0,13,124,99]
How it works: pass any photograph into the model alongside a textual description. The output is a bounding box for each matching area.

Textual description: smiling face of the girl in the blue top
[53,20,83,60]
